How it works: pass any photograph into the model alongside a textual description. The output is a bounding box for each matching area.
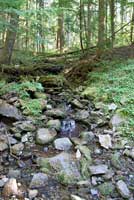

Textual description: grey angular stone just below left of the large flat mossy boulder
[30,173,48,189]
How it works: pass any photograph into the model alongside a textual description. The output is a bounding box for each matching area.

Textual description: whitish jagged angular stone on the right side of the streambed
[98,134,112,149]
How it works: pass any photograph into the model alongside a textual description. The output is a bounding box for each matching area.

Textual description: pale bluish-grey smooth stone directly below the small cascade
[54,137,73,151]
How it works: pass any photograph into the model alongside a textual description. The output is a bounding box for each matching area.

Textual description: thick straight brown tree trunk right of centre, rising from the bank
[97,0,105,57]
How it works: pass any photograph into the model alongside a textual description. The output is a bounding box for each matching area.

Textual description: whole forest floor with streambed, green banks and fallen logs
[0,46,134,200]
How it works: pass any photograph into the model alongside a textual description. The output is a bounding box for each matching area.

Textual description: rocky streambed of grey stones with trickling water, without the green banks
[0,85,134,200]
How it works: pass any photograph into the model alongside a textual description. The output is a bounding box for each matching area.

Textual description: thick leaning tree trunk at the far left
[0,13,19,64]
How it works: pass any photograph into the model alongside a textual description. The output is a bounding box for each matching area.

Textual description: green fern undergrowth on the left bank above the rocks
[0,81,43,116]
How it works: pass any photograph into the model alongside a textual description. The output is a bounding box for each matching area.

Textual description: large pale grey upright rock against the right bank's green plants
[109,113,125,128]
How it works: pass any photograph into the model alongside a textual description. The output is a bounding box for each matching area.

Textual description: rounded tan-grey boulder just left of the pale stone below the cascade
[36,128,57,145]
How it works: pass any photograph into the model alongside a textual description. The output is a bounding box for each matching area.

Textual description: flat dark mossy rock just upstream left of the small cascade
[45,109,66,118]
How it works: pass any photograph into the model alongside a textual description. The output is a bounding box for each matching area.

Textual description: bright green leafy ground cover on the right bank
[87,59,134,138]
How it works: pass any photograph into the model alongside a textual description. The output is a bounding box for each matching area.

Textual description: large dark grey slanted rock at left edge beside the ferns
[0,100,22,120]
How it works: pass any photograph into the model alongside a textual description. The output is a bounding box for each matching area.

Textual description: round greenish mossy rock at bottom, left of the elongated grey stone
[98,182,115,196]
